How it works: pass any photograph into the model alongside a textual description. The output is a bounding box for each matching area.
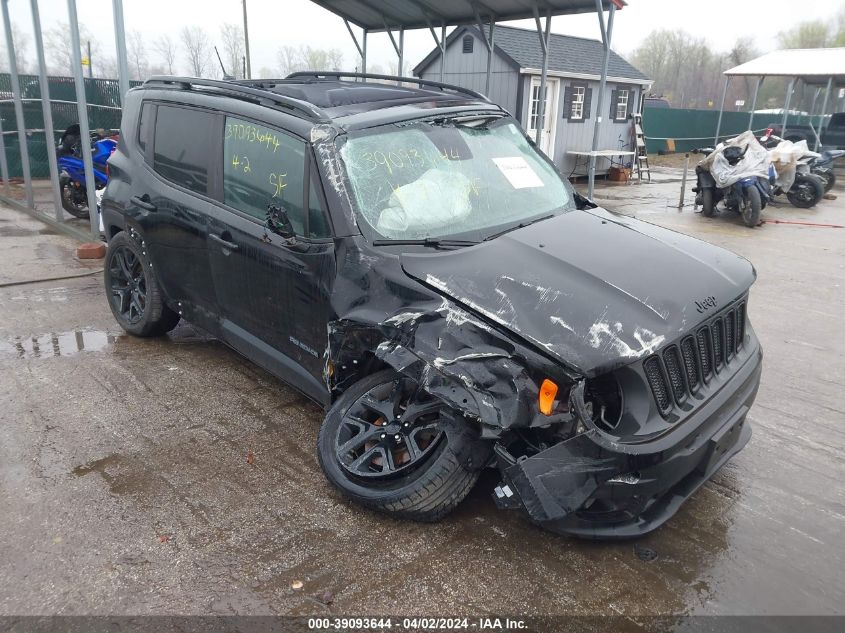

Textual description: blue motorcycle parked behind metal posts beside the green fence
[56,124,117,218]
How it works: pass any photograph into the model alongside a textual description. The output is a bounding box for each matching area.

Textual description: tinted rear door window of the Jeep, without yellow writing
[153,105,214,194]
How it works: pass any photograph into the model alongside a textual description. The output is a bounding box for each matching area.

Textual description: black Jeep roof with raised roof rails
[144,73,503,129]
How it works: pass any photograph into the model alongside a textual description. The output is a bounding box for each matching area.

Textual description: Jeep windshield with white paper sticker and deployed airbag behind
[340,118,573,240]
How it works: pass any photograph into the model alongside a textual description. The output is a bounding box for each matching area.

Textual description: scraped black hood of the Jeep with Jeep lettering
[402,209,755,376]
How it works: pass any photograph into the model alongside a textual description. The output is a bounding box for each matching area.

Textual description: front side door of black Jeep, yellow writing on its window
[209,116,335,400]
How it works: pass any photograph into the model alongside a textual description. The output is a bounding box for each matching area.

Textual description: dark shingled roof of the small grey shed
[414,25,649,82]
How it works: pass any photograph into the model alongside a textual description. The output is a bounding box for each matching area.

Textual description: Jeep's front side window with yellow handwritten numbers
[223,116,306,235]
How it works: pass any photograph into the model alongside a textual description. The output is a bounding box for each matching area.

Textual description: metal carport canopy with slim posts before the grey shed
[311,0,628,198]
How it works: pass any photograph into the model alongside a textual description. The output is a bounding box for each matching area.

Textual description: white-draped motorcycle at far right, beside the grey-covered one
[760,128,833,209]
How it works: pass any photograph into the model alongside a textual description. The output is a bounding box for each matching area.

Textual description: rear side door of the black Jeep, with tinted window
[131,103,223,331]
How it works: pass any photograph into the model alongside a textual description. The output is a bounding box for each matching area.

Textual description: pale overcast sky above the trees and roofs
[4,0,845,75]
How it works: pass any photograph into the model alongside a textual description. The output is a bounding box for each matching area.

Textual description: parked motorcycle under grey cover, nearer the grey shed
[692,131,771,227]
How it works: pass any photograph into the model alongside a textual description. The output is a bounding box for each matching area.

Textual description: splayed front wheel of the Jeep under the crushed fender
[317,369,484,522]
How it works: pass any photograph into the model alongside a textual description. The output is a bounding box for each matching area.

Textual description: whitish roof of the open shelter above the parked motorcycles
[725,48,845,83]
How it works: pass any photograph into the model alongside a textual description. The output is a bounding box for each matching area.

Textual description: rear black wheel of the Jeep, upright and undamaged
[104,231,180,337]
